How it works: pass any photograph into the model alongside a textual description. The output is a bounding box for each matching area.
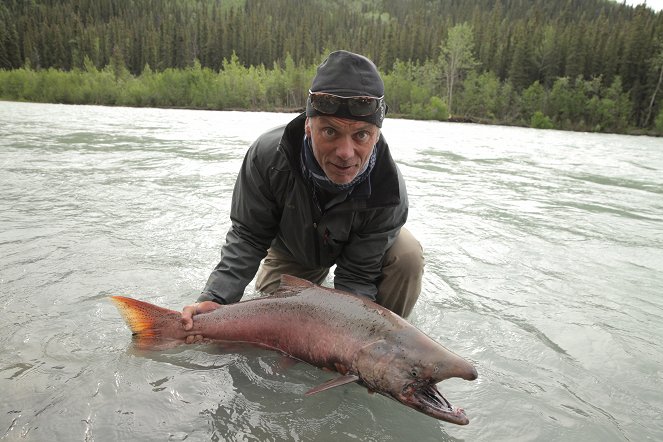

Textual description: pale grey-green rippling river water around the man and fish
[0,102,663,442]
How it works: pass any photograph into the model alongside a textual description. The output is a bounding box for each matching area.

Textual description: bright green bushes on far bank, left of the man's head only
[0,55,314,110]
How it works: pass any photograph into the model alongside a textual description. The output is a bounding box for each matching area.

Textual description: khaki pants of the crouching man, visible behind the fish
[256,228,424,317]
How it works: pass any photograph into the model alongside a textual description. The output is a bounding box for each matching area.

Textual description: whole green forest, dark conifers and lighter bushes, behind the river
[0,0,663,135]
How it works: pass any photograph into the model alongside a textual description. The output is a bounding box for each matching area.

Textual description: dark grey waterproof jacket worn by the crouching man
[198,114,408,304]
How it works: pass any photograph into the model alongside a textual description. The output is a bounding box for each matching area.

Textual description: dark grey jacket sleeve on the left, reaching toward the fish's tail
[198,137,280,304]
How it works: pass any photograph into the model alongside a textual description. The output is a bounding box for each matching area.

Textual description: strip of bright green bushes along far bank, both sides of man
[0,63,663,136]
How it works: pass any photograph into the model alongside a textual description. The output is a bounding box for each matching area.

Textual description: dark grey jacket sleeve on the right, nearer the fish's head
[334,167,408,301]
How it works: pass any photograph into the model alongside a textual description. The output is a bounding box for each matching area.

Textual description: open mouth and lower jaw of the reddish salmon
[400,382,470,425]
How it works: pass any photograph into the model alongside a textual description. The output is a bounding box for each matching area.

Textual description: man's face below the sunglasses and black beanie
[305,116,380,184]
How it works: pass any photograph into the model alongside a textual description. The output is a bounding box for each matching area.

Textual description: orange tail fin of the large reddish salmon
[111,296,185,349]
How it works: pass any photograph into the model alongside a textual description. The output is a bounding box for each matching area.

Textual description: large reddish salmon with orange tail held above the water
[112,275,477,425]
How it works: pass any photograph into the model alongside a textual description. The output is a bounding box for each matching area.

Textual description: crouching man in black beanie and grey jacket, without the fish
[182,51,424,330]
